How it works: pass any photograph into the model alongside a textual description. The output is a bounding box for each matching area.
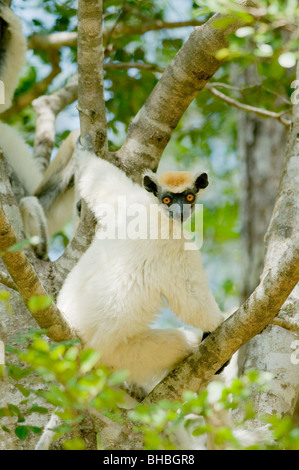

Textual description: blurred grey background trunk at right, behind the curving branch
[238,112,287,302]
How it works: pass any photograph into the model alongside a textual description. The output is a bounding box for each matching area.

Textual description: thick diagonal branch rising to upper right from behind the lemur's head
[117,2,256,181]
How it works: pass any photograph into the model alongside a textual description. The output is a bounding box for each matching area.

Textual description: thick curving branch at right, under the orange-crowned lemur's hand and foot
[147,60,299,401]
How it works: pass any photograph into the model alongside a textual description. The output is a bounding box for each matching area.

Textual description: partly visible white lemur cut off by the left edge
[0,0,78,257]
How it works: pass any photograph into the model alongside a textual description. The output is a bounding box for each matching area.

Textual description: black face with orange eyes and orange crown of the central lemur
[143,171,209,223]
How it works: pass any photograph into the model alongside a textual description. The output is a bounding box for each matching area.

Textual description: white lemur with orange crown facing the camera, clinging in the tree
[57,140,222,390]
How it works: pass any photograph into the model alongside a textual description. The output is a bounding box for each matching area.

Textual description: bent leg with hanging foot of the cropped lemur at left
[20,131,79,258]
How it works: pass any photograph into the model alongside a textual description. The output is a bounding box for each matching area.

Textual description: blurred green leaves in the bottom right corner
[131,370,299,450]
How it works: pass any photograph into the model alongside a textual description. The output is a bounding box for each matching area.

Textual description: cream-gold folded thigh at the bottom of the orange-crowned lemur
[99,328,201,389]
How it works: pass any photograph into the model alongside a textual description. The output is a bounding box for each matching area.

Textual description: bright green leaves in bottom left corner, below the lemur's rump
[0,330,126,448]
